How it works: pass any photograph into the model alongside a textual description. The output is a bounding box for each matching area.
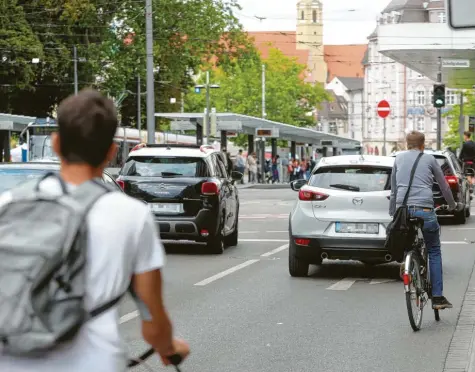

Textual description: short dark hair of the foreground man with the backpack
[58,89,118,167]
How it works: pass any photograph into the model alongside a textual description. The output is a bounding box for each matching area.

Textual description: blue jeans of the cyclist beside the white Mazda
[409,207,444,296]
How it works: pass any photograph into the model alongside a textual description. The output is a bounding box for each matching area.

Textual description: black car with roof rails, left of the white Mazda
[117,145,242,254]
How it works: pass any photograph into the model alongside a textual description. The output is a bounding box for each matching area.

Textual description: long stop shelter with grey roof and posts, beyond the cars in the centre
[155,113,361,157]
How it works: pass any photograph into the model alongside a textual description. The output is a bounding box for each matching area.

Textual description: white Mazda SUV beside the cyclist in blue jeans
[289,155,394,277]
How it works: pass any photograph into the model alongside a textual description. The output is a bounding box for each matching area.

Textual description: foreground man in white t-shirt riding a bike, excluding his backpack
[0,90,189,372]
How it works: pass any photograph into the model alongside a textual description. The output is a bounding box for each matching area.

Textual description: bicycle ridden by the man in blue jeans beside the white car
[402,205,449,332]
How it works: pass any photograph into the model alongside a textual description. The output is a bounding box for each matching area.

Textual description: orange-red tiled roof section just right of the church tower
[324,44,368,81]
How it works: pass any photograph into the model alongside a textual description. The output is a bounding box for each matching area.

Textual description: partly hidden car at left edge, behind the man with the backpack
[0,162,122,194]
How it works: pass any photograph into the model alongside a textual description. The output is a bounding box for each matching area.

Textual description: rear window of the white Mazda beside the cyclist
[309,166,392,192]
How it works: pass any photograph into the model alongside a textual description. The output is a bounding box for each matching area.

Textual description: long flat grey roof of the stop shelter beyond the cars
[155,112,361,147]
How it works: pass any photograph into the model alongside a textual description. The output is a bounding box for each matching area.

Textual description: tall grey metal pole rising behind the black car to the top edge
[145,0,155,144]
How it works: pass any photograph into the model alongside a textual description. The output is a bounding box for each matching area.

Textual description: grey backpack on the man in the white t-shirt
[0,173,122,357]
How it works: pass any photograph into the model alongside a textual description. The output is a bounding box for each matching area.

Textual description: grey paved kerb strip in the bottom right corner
[443,260,475,372]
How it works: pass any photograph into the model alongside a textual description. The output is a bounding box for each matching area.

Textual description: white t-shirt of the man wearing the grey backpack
[0,179,165,372]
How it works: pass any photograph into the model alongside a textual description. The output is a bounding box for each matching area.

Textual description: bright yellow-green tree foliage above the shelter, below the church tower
[185,49,330,146]
